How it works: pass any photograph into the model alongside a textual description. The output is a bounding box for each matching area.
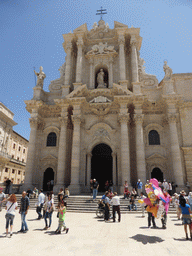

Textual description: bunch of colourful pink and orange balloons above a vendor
[138,179,170,218]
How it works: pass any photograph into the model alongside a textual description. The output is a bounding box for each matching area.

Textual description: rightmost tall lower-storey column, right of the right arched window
[168,114,184,186]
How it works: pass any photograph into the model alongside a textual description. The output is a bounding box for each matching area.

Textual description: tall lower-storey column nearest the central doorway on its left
[70,106,81,194]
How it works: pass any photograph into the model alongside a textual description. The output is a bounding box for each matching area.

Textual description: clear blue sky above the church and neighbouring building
[0,0,192,139]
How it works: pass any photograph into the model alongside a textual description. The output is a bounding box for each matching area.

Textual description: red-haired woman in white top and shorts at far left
[5,194,18,237]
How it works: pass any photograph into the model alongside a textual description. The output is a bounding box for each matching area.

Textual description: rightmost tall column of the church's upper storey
[131,38,139,82]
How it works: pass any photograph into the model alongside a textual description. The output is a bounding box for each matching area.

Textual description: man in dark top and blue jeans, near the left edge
[19,191,29,233]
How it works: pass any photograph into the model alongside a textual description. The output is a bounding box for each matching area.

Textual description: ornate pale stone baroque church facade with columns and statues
[24,20,192,194]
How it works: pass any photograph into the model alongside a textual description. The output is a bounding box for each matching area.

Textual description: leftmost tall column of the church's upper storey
[62,42,72,97]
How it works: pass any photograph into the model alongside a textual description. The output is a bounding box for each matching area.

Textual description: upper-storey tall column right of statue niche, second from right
[118,35,126,80]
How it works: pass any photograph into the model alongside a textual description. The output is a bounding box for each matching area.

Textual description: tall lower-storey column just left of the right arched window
[134,114,146,184]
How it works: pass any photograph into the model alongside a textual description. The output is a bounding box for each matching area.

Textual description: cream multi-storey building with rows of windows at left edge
[0,102,28,184]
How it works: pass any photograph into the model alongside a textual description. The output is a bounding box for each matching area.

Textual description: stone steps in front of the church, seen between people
[12,194,176,214]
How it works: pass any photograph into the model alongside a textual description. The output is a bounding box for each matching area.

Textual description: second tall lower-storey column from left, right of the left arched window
[54,112,68,192]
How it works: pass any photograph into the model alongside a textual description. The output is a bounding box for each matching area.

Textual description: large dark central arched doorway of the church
[91,143,113,191]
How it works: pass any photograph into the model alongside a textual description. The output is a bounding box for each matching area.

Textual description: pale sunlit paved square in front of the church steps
[0,210,192,256]
